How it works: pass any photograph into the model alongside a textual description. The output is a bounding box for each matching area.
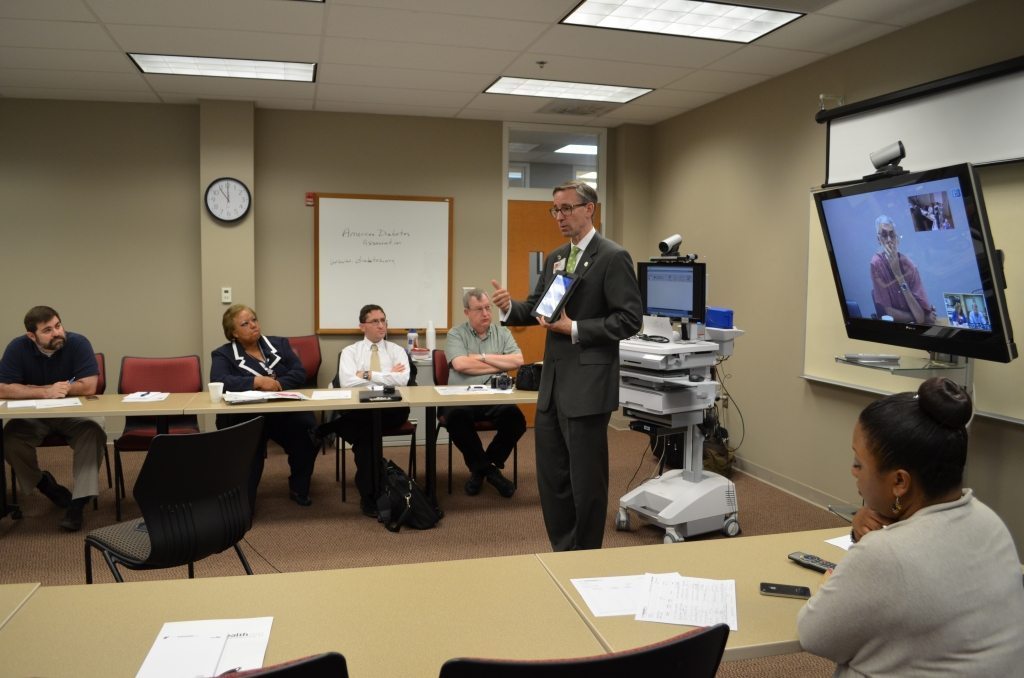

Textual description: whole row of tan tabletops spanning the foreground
[0,527,847,678]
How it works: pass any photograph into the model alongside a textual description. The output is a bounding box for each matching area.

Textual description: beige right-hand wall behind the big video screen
[649,0,1024,548]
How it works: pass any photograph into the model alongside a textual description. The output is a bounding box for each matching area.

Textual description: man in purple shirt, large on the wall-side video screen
[870,214,935,325]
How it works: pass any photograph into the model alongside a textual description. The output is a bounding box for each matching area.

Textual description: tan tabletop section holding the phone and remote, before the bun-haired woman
[538,527,849,660]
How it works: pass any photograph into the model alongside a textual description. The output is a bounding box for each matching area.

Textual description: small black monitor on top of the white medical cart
[637,260,708,323]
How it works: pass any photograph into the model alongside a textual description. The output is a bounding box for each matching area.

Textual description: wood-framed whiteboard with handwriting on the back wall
[313,194,455,334]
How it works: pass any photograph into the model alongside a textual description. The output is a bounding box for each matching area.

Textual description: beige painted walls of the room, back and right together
[0,0,1024,557]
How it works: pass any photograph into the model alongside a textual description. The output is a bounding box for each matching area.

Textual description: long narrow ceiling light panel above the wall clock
[128,52,316,82]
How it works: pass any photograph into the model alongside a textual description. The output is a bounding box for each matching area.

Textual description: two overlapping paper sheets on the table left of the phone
[571,573,739,631]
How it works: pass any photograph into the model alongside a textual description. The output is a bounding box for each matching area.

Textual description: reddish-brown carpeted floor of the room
[0,427,844,678]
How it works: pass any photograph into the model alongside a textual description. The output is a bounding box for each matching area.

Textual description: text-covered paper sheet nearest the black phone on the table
[636,573,739,631]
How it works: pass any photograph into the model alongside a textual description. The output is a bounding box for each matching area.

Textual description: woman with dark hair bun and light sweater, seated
[797,378,1024,678]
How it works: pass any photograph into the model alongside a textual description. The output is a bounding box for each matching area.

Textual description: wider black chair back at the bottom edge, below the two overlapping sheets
[440,624,729,678]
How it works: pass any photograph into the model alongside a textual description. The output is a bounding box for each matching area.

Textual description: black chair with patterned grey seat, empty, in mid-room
[85,417,263,584]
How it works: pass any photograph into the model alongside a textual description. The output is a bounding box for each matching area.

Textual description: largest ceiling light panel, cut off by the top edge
[561,0,803,43]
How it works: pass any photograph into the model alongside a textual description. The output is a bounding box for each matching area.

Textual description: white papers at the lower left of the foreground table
[135,617,273,678]
